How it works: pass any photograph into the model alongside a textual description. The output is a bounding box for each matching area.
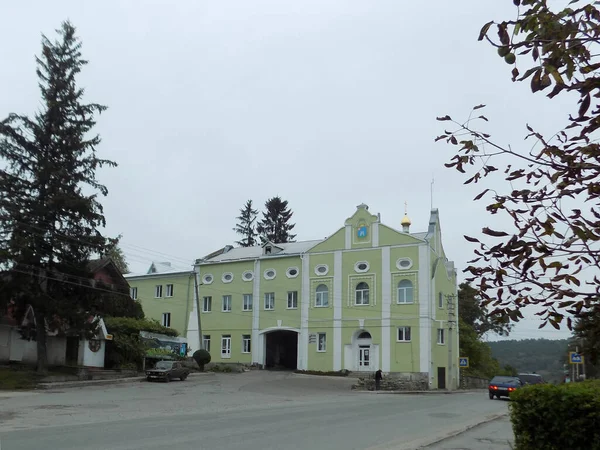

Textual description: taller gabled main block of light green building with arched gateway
[195,204,458,389]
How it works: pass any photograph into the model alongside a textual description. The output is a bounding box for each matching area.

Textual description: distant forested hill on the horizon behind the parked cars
[488,339,567,381]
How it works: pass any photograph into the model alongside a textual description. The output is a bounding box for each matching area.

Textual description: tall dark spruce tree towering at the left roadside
[0,22,116,372]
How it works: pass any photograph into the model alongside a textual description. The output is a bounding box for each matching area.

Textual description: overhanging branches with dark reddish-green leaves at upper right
[437,0,600,329]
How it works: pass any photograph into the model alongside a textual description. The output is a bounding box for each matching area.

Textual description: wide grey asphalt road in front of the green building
[0,372,506,450]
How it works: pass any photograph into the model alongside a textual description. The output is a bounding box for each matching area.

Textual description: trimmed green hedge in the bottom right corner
[509,380,600,450]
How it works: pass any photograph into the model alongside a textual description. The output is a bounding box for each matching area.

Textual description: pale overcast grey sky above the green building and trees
[0,0,572,339]
